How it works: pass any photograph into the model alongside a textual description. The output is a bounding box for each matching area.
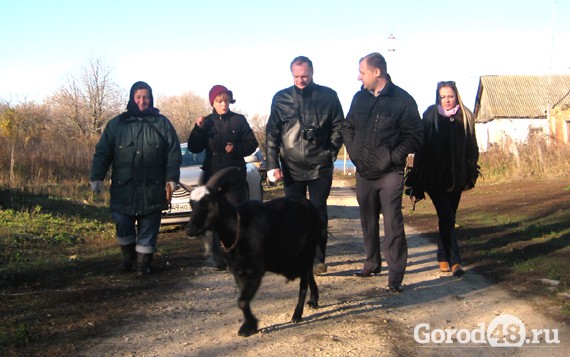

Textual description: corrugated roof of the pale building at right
[475,74,570,122]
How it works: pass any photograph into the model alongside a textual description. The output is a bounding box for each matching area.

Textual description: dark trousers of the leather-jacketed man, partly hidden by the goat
[285,175,332,263]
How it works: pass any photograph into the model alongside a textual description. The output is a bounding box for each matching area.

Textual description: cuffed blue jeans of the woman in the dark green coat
[111,211,162,253]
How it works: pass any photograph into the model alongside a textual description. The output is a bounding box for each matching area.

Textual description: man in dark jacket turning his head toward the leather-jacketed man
[343,53,423,292]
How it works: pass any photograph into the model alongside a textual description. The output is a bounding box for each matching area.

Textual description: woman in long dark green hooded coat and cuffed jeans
[90,82,181,275]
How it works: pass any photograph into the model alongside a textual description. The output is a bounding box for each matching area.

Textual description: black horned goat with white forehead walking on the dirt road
[187,168,323,336]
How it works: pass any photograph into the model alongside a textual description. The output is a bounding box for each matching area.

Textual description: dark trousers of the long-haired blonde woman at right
[428,192,462,266]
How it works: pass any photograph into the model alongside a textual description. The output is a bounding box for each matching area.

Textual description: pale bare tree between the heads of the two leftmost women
[155,92,212,142]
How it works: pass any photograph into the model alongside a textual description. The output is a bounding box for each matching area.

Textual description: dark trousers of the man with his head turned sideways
[356,172,408,286]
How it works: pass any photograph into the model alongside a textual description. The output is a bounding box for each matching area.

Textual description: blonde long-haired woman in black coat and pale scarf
[409,81,479,277]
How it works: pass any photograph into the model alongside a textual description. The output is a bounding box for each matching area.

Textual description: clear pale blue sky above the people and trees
[0,0,570,116]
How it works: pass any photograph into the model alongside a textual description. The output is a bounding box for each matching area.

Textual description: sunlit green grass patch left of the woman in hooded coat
[0,188,114,287]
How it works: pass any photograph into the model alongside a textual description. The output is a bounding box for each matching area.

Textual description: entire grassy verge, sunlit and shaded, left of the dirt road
[0,187,201,356]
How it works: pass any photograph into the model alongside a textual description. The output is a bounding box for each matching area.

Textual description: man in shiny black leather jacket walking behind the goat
[266,56,344,274]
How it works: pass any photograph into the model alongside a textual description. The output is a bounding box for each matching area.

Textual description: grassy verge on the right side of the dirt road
[404,180,570,319]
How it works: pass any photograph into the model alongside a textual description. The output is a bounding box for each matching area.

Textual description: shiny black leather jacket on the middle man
[266,83,344,181]
